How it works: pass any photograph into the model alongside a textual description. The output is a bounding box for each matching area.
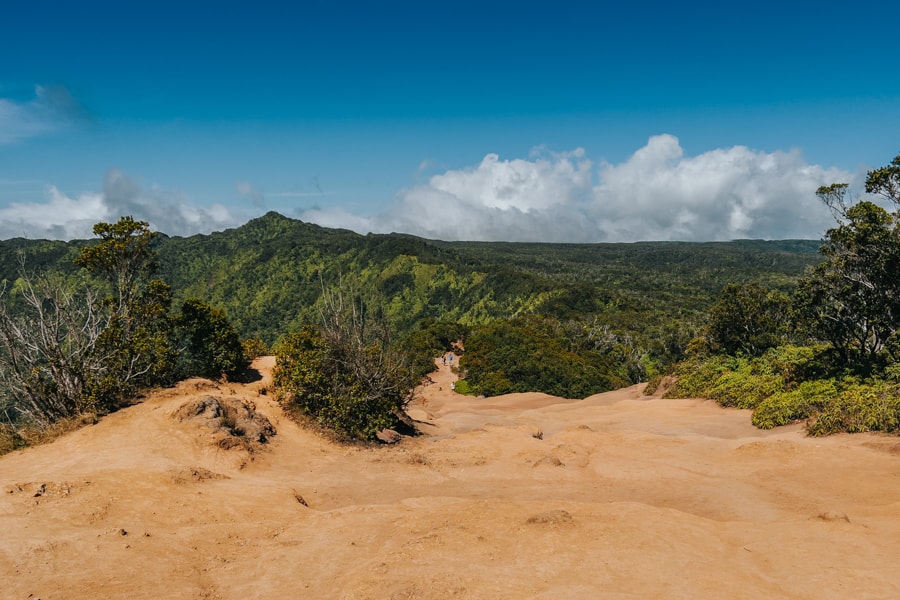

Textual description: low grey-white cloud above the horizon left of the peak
[0,169,247,240]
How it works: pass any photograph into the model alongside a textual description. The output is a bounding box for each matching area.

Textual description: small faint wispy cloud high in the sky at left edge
[0,85,90,144]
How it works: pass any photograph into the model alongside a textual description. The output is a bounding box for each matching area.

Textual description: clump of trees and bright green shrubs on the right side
[667,156,900,435]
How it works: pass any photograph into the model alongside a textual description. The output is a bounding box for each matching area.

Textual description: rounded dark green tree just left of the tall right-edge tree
[708,284,790,356]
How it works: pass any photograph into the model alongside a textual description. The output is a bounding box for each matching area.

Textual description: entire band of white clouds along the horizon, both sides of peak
[0,135,860,242]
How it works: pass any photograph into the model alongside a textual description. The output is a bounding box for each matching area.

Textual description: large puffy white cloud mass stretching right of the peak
[314,135,853,242]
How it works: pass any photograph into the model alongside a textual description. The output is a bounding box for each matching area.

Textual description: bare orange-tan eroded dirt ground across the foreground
[0,359,900,600]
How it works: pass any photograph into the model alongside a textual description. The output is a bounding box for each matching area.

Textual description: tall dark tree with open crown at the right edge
[795,156,900,373]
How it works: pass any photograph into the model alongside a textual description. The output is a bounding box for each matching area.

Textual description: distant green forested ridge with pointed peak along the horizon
[0,212,821,387]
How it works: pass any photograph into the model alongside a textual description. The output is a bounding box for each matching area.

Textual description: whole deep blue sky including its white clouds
[0,0,900,241]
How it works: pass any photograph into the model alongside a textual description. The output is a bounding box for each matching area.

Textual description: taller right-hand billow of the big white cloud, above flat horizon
[590,135,853,241]
